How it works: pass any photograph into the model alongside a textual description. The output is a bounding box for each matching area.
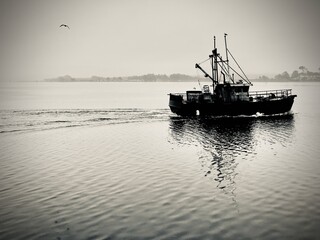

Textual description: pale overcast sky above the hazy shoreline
[0,0,320,81]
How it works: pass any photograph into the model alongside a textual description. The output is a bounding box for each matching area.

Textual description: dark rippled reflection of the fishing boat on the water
[170,114,294,192]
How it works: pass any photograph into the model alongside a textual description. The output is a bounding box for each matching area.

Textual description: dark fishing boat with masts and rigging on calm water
[169,34,297,116]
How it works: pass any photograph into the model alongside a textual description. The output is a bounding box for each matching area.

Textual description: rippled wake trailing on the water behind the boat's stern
[0,109,169,134]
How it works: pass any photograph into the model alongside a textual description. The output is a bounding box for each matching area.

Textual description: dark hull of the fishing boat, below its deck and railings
[169,94,296,116]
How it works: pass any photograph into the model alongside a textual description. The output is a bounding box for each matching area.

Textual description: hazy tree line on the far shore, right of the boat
[256,66,320,82]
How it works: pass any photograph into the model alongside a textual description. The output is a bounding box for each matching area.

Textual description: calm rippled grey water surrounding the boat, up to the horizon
[0,82,320,240]
